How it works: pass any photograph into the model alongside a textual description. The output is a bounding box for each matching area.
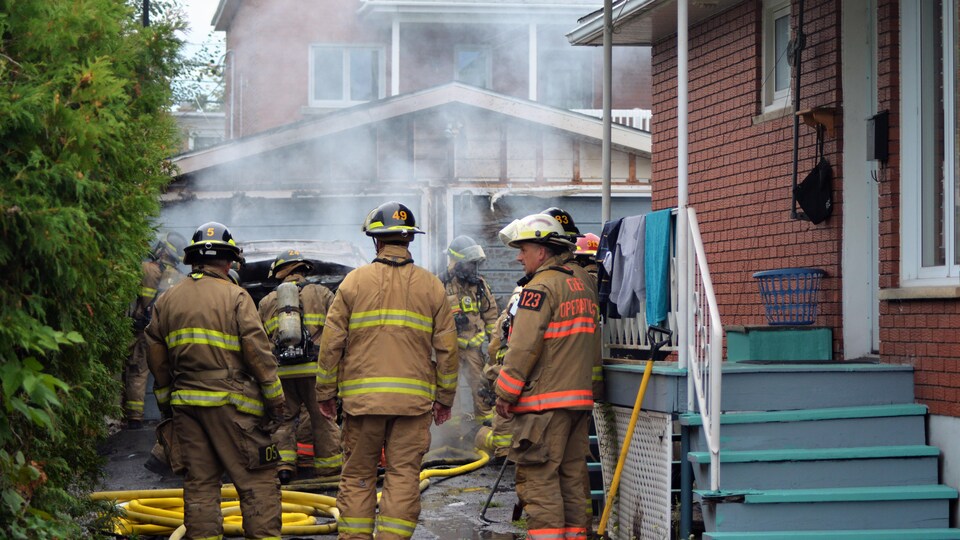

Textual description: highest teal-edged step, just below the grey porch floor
[679,403,927,452]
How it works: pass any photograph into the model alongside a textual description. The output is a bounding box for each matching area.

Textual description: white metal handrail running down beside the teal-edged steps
[686,207,723,491]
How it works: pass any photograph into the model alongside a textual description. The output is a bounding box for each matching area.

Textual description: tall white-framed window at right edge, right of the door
[900,0,960,286]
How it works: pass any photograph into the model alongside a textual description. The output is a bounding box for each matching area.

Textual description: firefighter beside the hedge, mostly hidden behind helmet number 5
[123,232,187,429]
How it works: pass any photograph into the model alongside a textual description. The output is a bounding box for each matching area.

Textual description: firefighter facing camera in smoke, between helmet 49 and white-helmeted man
[440,235,497,425]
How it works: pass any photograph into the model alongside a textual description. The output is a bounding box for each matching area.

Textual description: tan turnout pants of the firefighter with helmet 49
[337,413,432,540]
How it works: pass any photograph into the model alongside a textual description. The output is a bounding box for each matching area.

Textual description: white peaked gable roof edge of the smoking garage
[171,83,651,175]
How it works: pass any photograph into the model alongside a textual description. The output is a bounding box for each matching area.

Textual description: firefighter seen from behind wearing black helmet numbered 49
[317,202,458,540]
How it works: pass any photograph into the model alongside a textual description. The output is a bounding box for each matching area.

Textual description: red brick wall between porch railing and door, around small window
[652,0,843,358]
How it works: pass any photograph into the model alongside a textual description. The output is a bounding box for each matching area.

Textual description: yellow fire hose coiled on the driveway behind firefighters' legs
[90,448,490,540]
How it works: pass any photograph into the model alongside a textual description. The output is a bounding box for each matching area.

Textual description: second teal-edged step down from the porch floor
[688,445,940,491]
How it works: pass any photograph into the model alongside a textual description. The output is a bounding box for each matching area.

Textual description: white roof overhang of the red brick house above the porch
[567,0,745,46]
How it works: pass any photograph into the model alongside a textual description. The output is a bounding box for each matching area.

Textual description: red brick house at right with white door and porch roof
[568,0,960,523]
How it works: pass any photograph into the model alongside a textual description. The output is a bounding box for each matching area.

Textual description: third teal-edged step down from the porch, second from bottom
[694,485,957,532]
